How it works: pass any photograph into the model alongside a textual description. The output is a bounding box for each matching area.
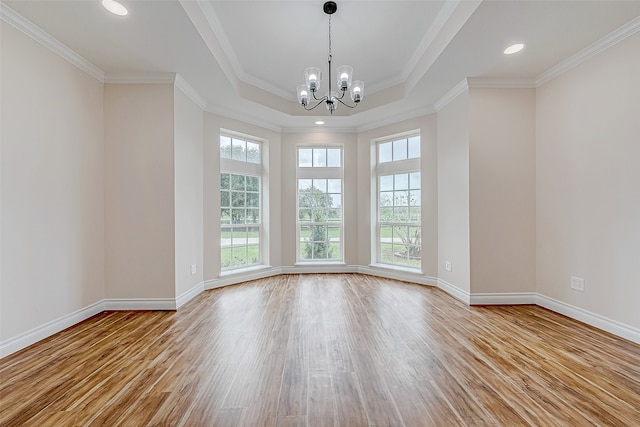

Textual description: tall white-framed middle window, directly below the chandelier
[297,147,342,262]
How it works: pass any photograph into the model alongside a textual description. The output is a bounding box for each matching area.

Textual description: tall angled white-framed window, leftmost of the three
[220,135,262,271]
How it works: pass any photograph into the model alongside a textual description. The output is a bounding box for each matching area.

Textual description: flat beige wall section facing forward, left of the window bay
[104,84,176,299]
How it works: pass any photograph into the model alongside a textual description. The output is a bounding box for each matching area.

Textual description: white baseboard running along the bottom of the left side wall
[0,301,105,358]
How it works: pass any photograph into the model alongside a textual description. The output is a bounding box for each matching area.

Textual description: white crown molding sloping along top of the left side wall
[0,2,104,83]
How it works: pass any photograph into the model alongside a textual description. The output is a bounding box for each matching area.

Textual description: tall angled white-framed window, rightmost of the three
[375,135,422,269]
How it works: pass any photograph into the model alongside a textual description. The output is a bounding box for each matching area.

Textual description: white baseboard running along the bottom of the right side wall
[536,294,640,344]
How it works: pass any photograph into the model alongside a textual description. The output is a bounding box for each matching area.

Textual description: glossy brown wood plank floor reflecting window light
[0,274,640,427]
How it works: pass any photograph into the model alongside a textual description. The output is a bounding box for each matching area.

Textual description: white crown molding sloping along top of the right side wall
[535,16,640,87]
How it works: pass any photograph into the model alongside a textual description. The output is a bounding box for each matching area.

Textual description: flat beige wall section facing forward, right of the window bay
[469,87,536,294]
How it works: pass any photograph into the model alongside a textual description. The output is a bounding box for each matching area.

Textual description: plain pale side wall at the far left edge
[0,22,105,344]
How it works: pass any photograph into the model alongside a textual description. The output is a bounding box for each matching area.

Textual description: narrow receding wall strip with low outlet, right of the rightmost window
[438,92,471,293]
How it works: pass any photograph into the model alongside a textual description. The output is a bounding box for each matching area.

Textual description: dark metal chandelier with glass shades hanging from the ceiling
[297,1,364,114]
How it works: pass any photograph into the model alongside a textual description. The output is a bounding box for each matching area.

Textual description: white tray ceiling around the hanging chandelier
[3,0,640,130]
